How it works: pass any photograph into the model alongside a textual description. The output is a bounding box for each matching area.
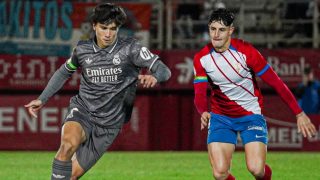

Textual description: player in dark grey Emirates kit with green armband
[25,3,171,179]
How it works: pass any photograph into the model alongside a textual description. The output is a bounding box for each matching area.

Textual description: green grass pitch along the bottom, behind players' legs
[0,151,320,180]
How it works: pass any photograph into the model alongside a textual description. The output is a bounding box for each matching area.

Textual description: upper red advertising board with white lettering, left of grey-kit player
[0,55,80,90]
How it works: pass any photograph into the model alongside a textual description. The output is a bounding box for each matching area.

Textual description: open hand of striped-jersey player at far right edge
[296,112,317,137]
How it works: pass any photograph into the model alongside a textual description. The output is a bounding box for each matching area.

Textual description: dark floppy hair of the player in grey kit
[91,3,127,26]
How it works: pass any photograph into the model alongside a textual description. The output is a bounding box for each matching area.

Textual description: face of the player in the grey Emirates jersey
[93,22,118,48]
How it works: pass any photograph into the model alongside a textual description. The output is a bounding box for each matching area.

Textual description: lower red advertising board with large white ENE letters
[0,95,149,150]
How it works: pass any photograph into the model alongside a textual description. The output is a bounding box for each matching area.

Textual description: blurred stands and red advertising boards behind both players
[0,0,320,151]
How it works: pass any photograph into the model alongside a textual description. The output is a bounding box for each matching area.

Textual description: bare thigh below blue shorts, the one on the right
[244,141,267,171]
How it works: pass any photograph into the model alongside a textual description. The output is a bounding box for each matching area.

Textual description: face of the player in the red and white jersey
[209,21,234,52]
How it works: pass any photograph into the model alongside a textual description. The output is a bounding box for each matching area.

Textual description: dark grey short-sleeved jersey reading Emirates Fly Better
[65,37,161,127]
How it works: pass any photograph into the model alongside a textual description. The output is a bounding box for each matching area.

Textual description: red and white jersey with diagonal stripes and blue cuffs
[194,39,269,117]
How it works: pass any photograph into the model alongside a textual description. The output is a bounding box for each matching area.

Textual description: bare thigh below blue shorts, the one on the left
[208,142,235,172]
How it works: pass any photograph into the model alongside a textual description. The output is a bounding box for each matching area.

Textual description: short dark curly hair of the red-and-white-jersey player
[208,8,234,26]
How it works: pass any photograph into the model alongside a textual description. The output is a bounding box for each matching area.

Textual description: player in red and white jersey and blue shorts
[194,9,316,180]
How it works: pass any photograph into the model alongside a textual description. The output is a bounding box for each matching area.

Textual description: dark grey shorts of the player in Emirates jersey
[64,107,120,171]
